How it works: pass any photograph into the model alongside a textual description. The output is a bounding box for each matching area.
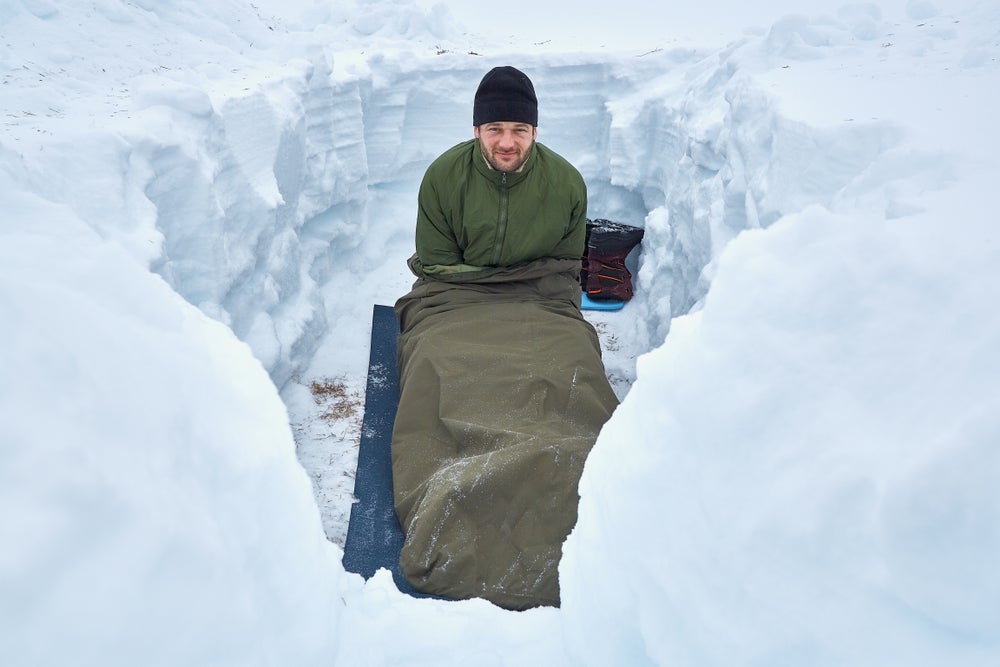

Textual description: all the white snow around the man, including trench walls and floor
[0,0,1000,666]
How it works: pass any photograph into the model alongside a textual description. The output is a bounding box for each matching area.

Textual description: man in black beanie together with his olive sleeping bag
[392,67,617,609]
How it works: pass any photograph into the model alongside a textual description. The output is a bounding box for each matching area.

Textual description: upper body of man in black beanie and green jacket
[416,67,587,277]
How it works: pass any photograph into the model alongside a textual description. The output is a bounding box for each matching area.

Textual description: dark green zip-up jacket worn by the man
[416,139,587,280]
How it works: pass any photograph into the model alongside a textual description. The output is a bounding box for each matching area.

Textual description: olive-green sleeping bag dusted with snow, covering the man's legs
[392,259,617,609]
